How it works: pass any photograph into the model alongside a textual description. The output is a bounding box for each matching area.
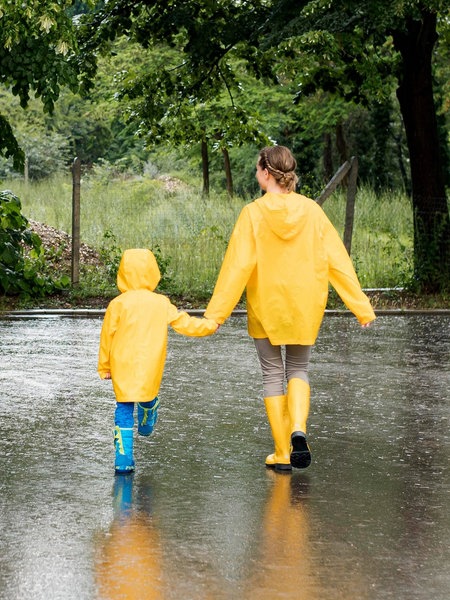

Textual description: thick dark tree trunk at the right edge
[393,10,450,292]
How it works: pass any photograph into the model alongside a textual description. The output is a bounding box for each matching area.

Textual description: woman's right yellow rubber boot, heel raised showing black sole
[287,378,311,469]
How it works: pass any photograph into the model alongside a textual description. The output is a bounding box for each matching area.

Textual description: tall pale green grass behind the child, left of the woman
[4,177,244,299]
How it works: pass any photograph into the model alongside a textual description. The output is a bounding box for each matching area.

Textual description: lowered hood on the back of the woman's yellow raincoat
[255,192,307,240]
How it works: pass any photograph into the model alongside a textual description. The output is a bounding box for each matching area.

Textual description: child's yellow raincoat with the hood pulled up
[98,249,217,402]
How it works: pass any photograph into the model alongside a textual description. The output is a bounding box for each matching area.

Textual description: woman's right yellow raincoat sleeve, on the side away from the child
[324,218,375,325]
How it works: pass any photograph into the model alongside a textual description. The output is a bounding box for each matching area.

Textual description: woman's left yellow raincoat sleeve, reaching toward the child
[205,208,256,324]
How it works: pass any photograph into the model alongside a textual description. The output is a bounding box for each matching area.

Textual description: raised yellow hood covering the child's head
[117,248,161,292]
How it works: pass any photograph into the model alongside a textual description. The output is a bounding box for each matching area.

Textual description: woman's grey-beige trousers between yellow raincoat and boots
[254,338,311,398]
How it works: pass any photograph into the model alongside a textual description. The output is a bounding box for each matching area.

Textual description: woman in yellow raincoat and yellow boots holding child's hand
[205,146,375,471]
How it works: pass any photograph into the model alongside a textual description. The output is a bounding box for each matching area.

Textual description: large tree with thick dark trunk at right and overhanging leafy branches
[81,0,450,291]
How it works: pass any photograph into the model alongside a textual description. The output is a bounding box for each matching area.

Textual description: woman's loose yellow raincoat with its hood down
[205,192,375,345]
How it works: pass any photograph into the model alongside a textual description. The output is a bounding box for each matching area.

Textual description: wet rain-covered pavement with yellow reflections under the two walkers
[0,315,450,600]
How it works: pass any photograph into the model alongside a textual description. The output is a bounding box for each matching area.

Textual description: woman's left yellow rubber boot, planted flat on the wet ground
[264,396,292,471]
